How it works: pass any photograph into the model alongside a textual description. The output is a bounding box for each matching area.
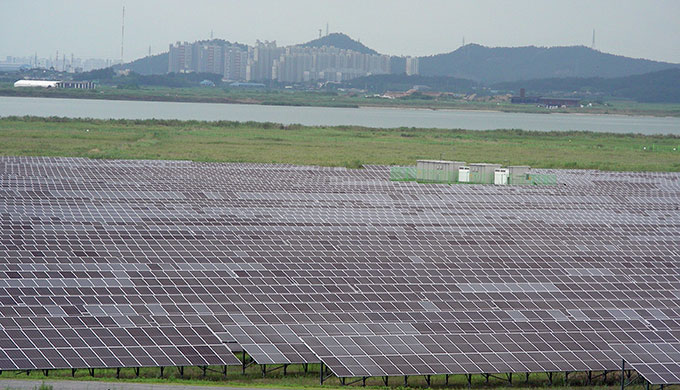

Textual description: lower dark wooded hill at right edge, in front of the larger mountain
[492,68,680,103]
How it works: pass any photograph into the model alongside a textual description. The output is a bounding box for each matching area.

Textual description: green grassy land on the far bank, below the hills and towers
[0,83,680,117]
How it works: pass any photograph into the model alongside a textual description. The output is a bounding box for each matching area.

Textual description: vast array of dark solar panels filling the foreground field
[0,157,680,384]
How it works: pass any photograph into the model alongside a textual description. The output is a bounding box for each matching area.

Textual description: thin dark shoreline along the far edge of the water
[0,90,680,118]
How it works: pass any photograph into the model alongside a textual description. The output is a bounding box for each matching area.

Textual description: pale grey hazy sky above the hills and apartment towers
[0,0,680,63]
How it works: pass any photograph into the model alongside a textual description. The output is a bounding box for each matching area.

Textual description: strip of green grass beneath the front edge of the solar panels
[0,364,677,390]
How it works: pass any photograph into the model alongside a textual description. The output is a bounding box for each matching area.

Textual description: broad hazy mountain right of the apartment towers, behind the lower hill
[420,44,680,83]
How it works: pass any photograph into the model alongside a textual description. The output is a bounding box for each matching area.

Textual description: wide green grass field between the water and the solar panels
[0,118,680,171]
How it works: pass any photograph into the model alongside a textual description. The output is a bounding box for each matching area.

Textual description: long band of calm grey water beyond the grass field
[0,97,680,135]
